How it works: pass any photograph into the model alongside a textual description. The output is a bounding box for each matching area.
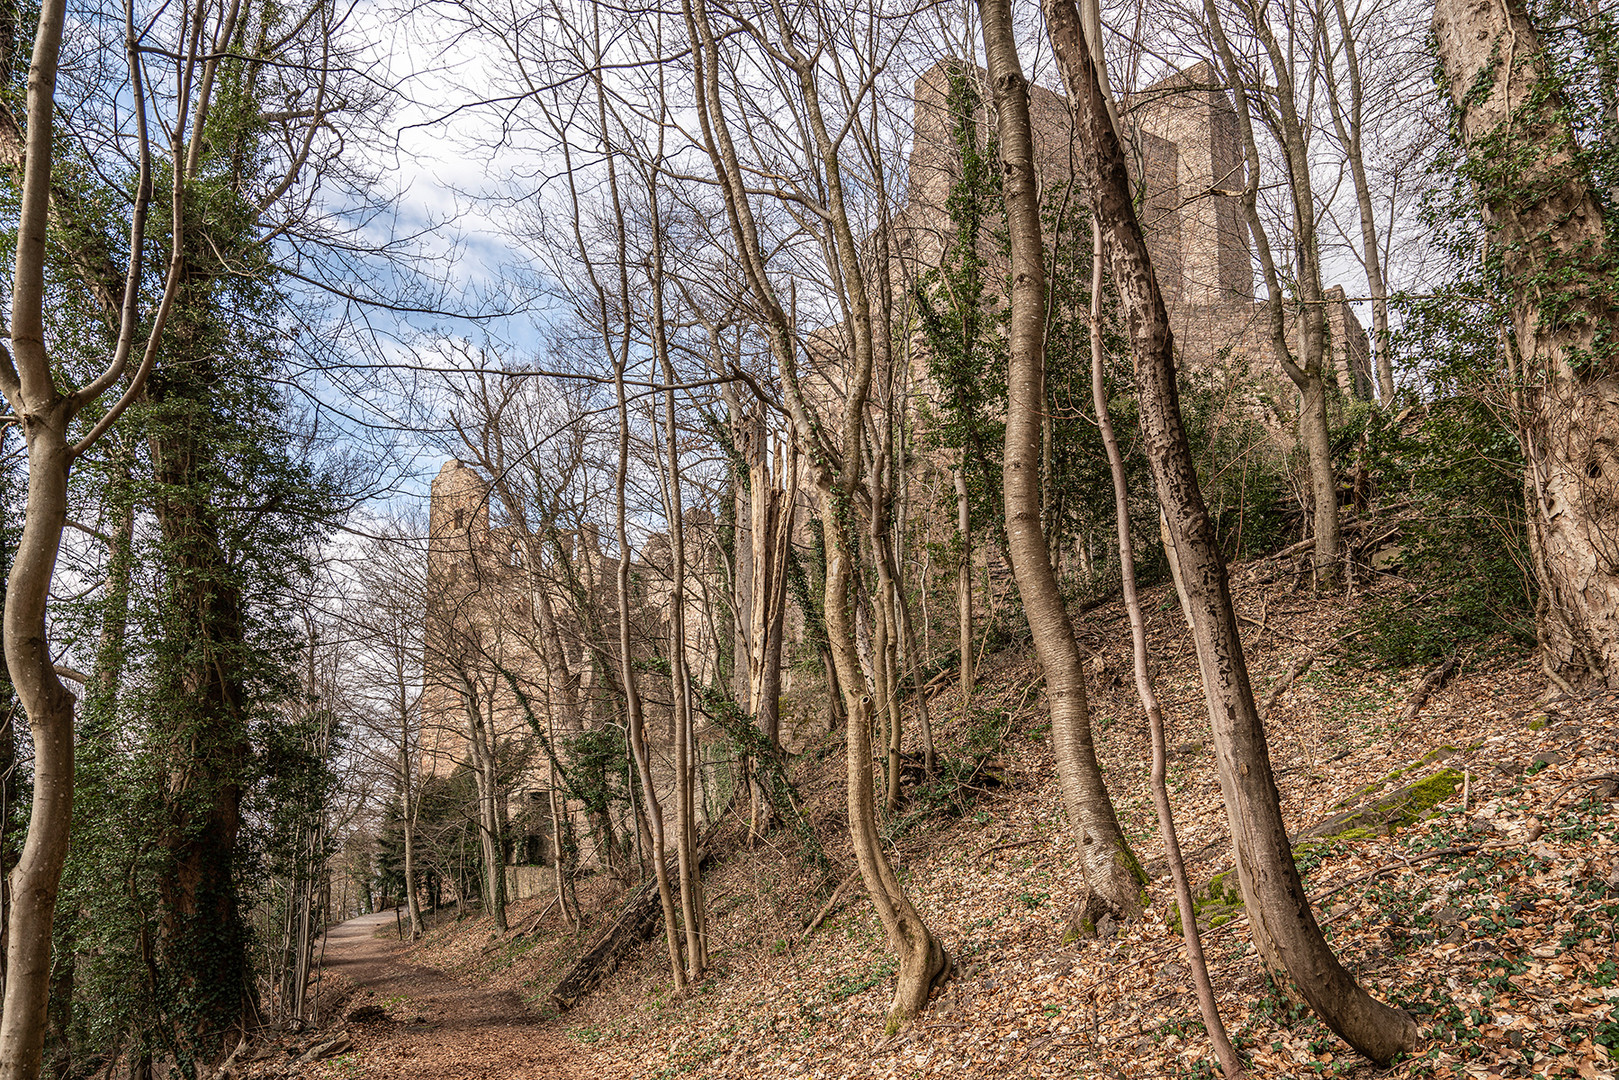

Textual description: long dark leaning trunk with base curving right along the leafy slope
[1043,0,1418,1064]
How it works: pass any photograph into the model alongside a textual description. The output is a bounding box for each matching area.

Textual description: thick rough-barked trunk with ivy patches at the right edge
[1433,0,1619,687]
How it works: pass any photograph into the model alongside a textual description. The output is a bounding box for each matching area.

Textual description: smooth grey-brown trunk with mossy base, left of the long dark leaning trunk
[978,0,1145,933]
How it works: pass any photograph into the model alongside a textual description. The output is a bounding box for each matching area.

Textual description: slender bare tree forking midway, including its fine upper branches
[682,0,949,1022]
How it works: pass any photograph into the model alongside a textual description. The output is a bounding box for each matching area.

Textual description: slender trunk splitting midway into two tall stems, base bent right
[682,0,949,1022]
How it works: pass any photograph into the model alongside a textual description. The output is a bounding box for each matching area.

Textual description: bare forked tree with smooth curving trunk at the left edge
[0,0,218,1062]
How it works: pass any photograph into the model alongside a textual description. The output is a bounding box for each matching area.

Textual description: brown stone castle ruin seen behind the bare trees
[423,63,1371,895]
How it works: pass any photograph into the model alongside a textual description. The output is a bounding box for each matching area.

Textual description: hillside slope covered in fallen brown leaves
[294,563,1619,1080]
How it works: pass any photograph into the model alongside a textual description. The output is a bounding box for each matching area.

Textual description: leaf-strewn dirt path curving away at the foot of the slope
[298,912,594,1080]
